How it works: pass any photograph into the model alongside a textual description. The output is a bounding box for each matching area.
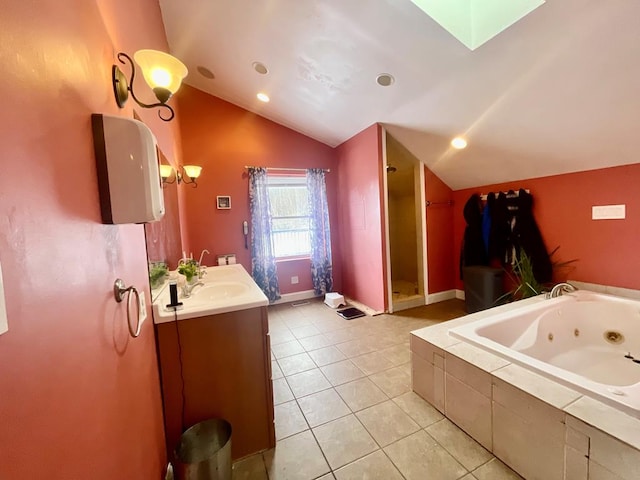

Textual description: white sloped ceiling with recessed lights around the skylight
[160,0,640,189]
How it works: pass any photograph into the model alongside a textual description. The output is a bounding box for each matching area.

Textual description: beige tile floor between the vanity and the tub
[233,300,520,480]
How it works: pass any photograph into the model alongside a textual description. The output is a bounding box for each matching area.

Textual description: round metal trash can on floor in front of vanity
[175,418,231,480]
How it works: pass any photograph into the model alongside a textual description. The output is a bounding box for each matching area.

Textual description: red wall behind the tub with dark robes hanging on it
[453,164,640,289]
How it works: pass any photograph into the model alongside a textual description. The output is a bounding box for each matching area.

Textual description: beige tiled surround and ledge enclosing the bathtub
[411,288,640,480]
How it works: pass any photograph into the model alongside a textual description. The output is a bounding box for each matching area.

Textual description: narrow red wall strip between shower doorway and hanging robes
[424,167,456,293]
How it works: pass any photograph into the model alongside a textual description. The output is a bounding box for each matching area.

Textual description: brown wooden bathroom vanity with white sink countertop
[153,265,275,460]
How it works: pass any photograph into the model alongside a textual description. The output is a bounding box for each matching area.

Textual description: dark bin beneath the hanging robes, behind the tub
[462,266,503,313]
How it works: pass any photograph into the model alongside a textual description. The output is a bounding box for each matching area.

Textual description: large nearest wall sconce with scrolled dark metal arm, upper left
[111,50,188,122]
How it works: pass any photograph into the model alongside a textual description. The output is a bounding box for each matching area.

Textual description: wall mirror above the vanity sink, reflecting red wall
[144,149,182,301]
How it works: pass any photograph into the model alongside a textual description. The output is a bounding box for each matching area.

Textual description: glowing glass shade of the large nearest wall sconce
[133,50,189,94]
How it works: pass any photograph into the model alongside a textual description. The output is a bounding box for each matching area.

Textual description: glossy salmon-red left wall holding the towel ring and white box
[0,0,178,480]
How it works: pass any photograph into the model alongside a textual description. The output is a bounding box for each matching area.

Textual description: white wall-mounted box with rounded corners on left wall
[91,113,164,223]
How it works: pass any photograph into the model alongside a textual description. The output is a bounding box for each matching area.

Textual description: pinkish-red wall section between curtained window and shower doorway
[336,124,388,311]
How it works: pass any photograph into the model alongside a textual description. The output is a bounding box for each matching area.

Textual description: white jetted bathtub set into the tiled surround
[449,290,640,418]
